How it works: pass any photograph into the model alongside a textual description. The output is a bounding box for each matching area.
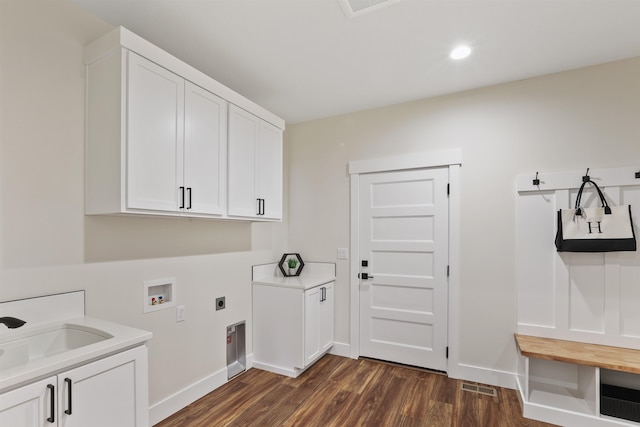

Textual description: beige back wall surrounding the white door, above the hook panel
[286,58,640,382]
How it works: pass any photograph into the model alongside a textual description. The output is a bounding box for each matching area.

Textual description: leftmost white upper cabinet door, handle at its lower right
[126,52,185,211]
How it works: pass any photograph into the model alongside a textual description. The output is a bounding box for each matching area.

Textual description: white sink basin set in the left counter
[0,323,113,371]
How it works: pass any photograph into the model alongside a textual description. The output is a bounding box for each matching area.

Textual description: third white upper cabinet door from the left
[228,105,260,217]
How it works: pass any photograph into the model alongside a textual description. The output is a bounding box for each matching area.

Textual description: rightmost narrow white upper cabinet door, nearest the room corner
[258,121,282,219]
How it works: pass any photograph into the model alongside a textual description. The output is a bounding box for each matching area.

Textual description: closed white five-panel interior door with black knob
[359,168,449,371]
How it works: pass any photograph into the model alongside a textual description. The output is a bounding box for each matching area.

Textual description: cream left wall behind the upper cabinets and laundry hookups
[0,0,286,422]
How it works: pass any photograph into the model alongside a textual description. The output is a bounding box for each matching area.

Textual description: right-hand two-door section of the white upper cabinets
[228,105,282,220]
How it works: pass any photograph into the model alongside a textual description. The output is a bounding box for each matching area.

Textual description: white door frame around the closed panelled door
[349,148,462,378]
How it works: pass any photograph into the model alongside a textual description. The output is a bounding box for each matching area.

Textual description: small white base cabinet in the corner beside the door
[253,281,334,378]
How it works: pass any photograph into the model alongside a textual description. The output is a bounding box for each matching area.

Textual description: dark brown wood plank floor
[156,355,549,427]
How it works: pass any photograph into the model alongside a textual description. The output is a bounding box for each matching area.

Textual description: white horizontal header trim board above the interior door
[349,148,462,176]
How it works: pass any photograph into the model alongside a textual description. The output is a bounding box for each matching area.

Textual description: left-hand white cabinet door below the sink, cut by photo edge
[0,376,58,427]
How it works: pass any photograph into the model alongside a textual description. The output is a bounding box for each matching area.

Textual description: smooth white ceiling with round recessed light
[73,0,640,123]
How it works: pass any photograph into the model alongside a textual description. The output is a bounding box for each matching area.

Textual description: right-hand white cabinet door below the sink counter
[58,347,148,427]
